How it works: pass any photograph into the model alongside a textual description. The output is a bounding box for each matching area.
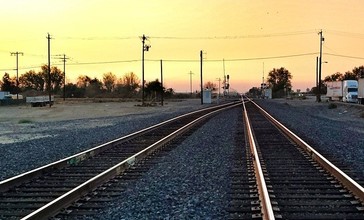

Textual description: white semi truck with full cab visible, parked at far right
[326,80,358,102]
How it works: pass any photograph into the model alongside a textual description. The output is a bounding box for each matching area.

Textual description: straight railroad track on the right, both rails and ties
[242,99,364,219]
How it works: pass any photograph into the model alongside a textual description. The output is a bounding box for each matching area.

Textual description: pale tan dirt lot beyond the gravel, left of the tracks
[0,99,199,123]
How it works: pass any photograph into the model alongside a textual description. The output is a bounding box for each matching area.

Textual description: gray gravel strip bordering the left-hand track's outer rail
[0,104,208,181]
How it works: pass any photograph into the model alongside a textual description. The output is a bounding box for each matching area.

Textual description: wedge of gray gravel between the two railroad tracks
[93,108,242,219]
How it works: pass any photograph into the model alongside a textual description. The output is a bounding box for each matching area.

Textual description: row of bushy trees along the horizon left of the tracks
[0,65,174,98]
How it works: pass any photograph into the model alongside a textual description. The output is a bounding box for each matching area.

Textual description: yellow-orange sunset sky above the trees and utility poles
[0,0,364,92]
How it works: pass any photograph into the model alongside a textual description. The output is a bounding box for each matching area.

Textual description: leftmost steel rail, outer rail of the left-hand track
[0,103,237,192]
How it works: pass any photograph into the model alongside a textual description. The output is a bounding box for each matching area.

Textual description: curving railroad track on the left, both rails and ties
[0,102,245,219]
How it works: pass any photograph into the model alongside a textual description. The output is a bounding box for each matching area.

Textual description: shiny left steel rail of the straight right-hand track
[243,102,275,220]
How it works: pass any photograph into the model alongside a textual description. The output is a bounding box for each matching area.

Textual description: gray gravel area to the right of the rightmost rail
[255,97,364,181]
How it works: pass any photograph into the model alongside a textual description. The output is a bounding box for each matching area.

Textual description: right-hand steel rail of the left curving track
[22,103,241,220]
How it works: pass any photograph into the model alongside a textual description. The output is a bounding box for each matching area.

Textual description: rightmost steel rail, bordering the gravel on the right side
[252,101,364,203]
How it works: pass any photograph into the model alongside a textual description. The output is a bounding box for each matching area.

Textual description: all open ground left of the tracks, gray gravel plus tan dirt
[0,99,208,180]
